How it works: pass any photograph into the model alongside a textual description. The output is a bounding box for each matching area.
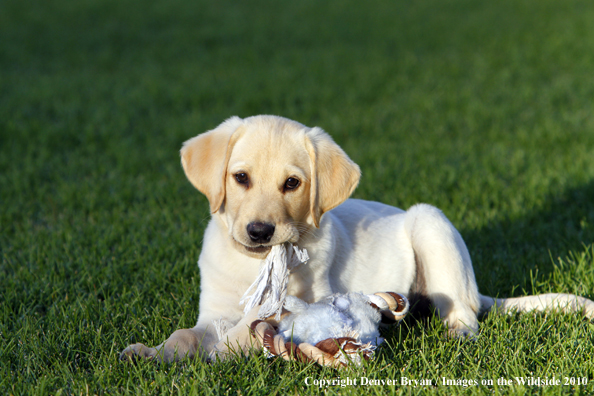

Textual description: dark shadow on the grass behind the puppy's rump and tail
[461,181,594,297]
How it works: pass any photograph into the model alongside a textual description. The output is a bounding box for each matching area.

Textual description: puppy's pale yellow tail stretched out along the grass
[480,293,594,319]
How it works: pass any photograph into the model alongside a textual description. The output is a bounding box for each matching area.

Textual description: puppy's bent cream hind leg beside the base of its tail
[404,204,480,336]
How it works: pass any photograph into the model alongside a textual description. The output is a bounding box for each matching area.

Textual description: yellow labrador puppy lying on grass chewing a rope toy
[122,116,594,361]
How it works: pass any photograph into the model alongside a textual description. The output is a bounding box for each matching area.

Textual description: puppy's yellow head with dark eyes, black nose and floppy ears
[181,116,360,258]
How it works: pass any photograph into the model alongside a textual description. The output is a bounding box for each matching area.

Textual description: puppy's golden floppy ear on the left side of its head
[180,117,243,213]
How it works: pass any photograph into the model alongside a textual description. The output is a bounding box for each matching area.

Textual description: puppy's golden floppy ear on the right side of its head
[305,127,361,227]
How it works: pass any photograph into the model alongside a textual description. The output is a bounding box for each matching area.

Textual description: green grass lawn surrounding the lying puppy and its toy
[0,0,594,395]
